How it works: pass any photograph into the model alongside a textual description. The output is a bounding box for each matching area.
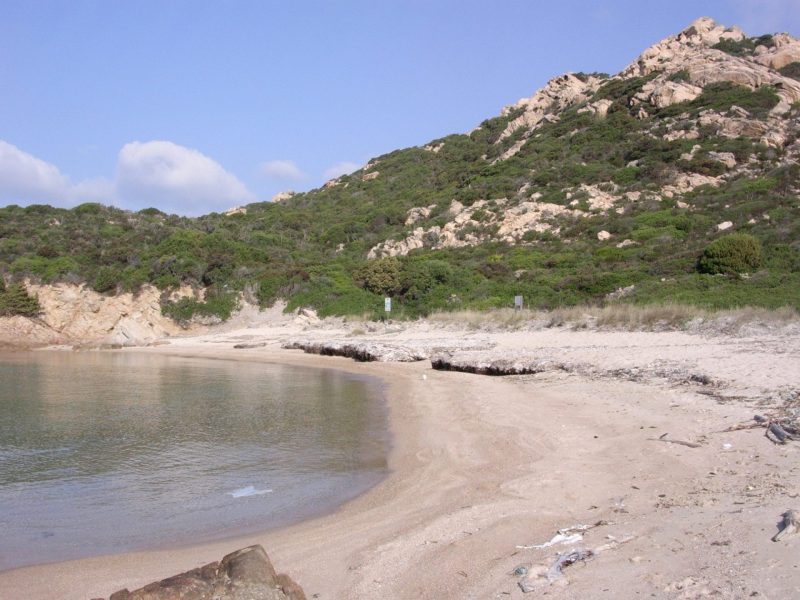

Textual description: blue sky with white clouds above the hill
[0,0,800,215]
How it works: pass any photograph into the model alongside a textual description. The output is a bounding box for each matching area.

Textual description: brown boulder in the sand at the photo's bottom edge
[104,545,306,600]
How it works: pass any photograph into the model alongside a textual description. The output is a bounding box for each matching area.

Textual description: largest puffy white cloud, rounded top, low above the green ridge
[116,141,256,215]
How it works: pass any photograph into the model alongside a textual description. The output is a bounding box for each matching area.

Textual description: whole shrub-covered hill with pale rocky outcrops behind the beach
[0,19,800,320]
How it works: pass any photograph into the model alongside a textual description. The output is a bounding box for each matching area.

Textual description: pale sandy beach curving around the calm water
[0,319,800,599]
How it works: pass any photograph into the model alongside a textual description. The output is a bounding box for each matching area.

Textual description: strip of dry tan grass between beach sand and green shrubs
[427,304,800,333]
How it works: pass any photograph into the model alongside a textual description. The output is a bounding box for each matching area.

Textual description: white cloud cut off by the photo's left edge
[0,140,72,204]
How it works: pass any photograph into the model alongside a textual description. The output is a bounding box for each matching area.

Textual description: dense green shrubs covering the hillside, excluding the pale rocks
[0,66,800,321]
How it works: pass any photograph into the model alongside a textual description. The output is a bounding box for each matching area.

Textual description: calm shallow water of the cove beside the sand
[0,352,387,570]
